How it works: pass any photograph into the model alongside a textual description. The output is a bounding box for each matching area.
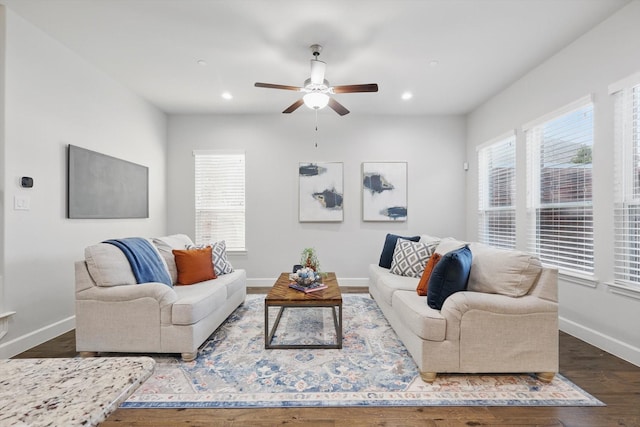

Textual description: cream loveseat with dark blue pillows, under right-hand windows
[369,236,558,382]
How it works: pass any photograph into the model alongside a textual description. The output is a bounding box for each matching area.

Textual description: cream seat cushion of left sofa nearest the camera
[171,279,227,325]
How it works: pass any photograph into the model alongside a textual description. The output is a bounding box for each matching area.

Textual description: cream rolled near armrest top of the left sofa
[76,282,178,307]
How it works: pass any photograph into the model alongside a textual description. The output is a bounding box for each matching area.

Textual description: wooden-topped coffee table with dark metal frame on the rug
[264,273,342,349]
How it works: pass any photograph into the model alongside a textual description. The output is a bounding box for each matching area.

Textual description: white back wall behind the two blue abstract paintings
[168,112,465,285]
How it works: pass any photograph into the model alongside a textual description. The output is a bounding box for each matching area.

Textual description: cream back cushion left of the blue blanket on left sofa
[84,243,137,286]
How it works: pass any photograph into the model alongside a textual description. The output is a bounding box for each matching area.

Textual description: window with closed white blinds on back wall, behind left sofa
[193,151,246,251]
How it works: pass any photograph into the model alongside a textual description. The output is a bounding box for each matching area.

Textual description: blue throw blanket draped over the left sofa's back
[103,237,173,286]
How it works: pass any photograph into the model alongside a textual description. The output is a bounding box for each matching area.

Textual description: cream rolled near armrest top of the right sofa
[441,291,558,323]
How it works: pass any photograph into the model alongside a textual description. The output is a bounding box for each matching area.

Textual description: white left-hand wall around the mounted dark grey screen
[0,10,167,357]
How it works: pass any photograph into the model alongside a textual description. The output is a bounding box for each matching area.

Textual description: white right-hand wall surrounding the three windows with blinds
[466,1,640,365]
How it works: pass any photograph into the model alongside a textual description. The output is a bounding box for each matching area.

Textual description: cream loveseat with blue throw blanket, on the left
[75,234,246,361]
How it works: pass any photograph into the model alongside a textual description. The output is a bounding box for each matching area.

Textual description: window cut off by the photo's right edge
[610,74,640,285]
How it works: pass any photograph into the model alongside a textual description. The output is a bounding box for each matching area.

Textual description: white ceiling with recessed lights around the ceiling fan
[0,0,629,114]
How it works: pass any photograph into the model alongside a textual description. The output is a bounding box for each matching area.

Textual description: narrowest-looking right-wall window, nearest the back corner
[478,134,516,248]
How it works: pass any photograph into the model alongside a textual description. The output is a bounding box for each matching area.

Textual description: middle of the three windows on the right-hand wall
[525,97,593,274]
